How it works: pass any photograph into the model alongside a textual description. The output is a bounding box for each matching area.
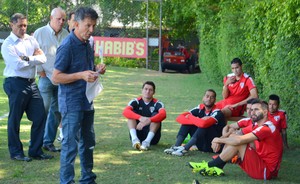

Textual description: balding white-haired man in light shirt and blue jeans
[33,7,69,152]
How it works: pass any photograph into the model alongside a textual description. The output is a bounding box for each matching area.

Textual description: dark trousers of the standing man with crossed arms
[3,77,47,158]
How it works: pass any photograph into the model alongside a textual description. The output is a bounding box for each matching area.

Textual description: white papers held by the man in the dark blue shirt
[85,77,103,103]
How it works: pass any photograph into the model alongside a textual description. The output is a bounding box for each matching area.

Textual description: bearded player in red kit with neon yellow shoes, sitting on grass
[189,99,283,180]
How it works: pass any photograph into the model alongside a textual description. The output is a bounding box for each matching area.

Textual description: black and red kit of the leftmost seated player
[123,97,166,145]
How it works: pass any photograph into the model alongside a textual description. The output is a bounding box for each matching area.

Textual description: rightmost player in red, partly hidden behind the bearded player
[268,94,289,149]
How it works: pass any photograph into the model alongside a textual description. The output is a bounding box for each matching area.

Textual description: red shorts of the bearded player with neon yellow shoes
[239,145,272,180]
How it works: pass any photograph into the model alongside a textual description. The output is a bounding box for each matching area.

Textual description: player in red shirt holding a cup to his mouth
[216,58,258,121]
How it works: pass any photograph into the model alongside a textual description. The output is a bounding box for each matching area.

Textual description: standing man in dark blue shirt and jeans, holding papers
[52,7,105,184]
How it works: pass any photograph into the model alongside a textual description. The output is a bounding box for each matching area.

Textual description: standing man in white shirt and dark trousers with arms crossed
[1,13,53,162]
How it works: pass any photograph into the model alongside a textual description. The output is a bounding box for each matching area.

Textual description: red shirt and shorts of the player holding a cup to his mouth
[216,73,256,117]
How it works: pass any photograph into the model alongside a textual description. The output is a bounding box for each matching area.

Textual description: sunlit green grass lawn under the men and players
[0,62,300,184]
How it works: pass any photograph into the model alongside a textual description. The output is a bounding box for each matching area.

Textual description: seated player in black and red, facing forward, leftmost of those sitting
[123,81,166,150]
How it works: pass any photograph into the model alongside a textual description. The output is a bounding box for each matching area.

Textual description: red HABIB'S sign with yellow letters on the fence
[94,36,147,58]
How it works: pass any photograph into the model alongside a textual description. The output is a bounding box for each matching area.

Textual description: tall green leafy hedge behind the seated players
[197,0,300,137]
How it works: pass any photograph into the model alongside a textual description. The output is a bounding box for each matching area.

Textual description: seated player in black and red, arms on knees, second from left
[164,89,225,156]
